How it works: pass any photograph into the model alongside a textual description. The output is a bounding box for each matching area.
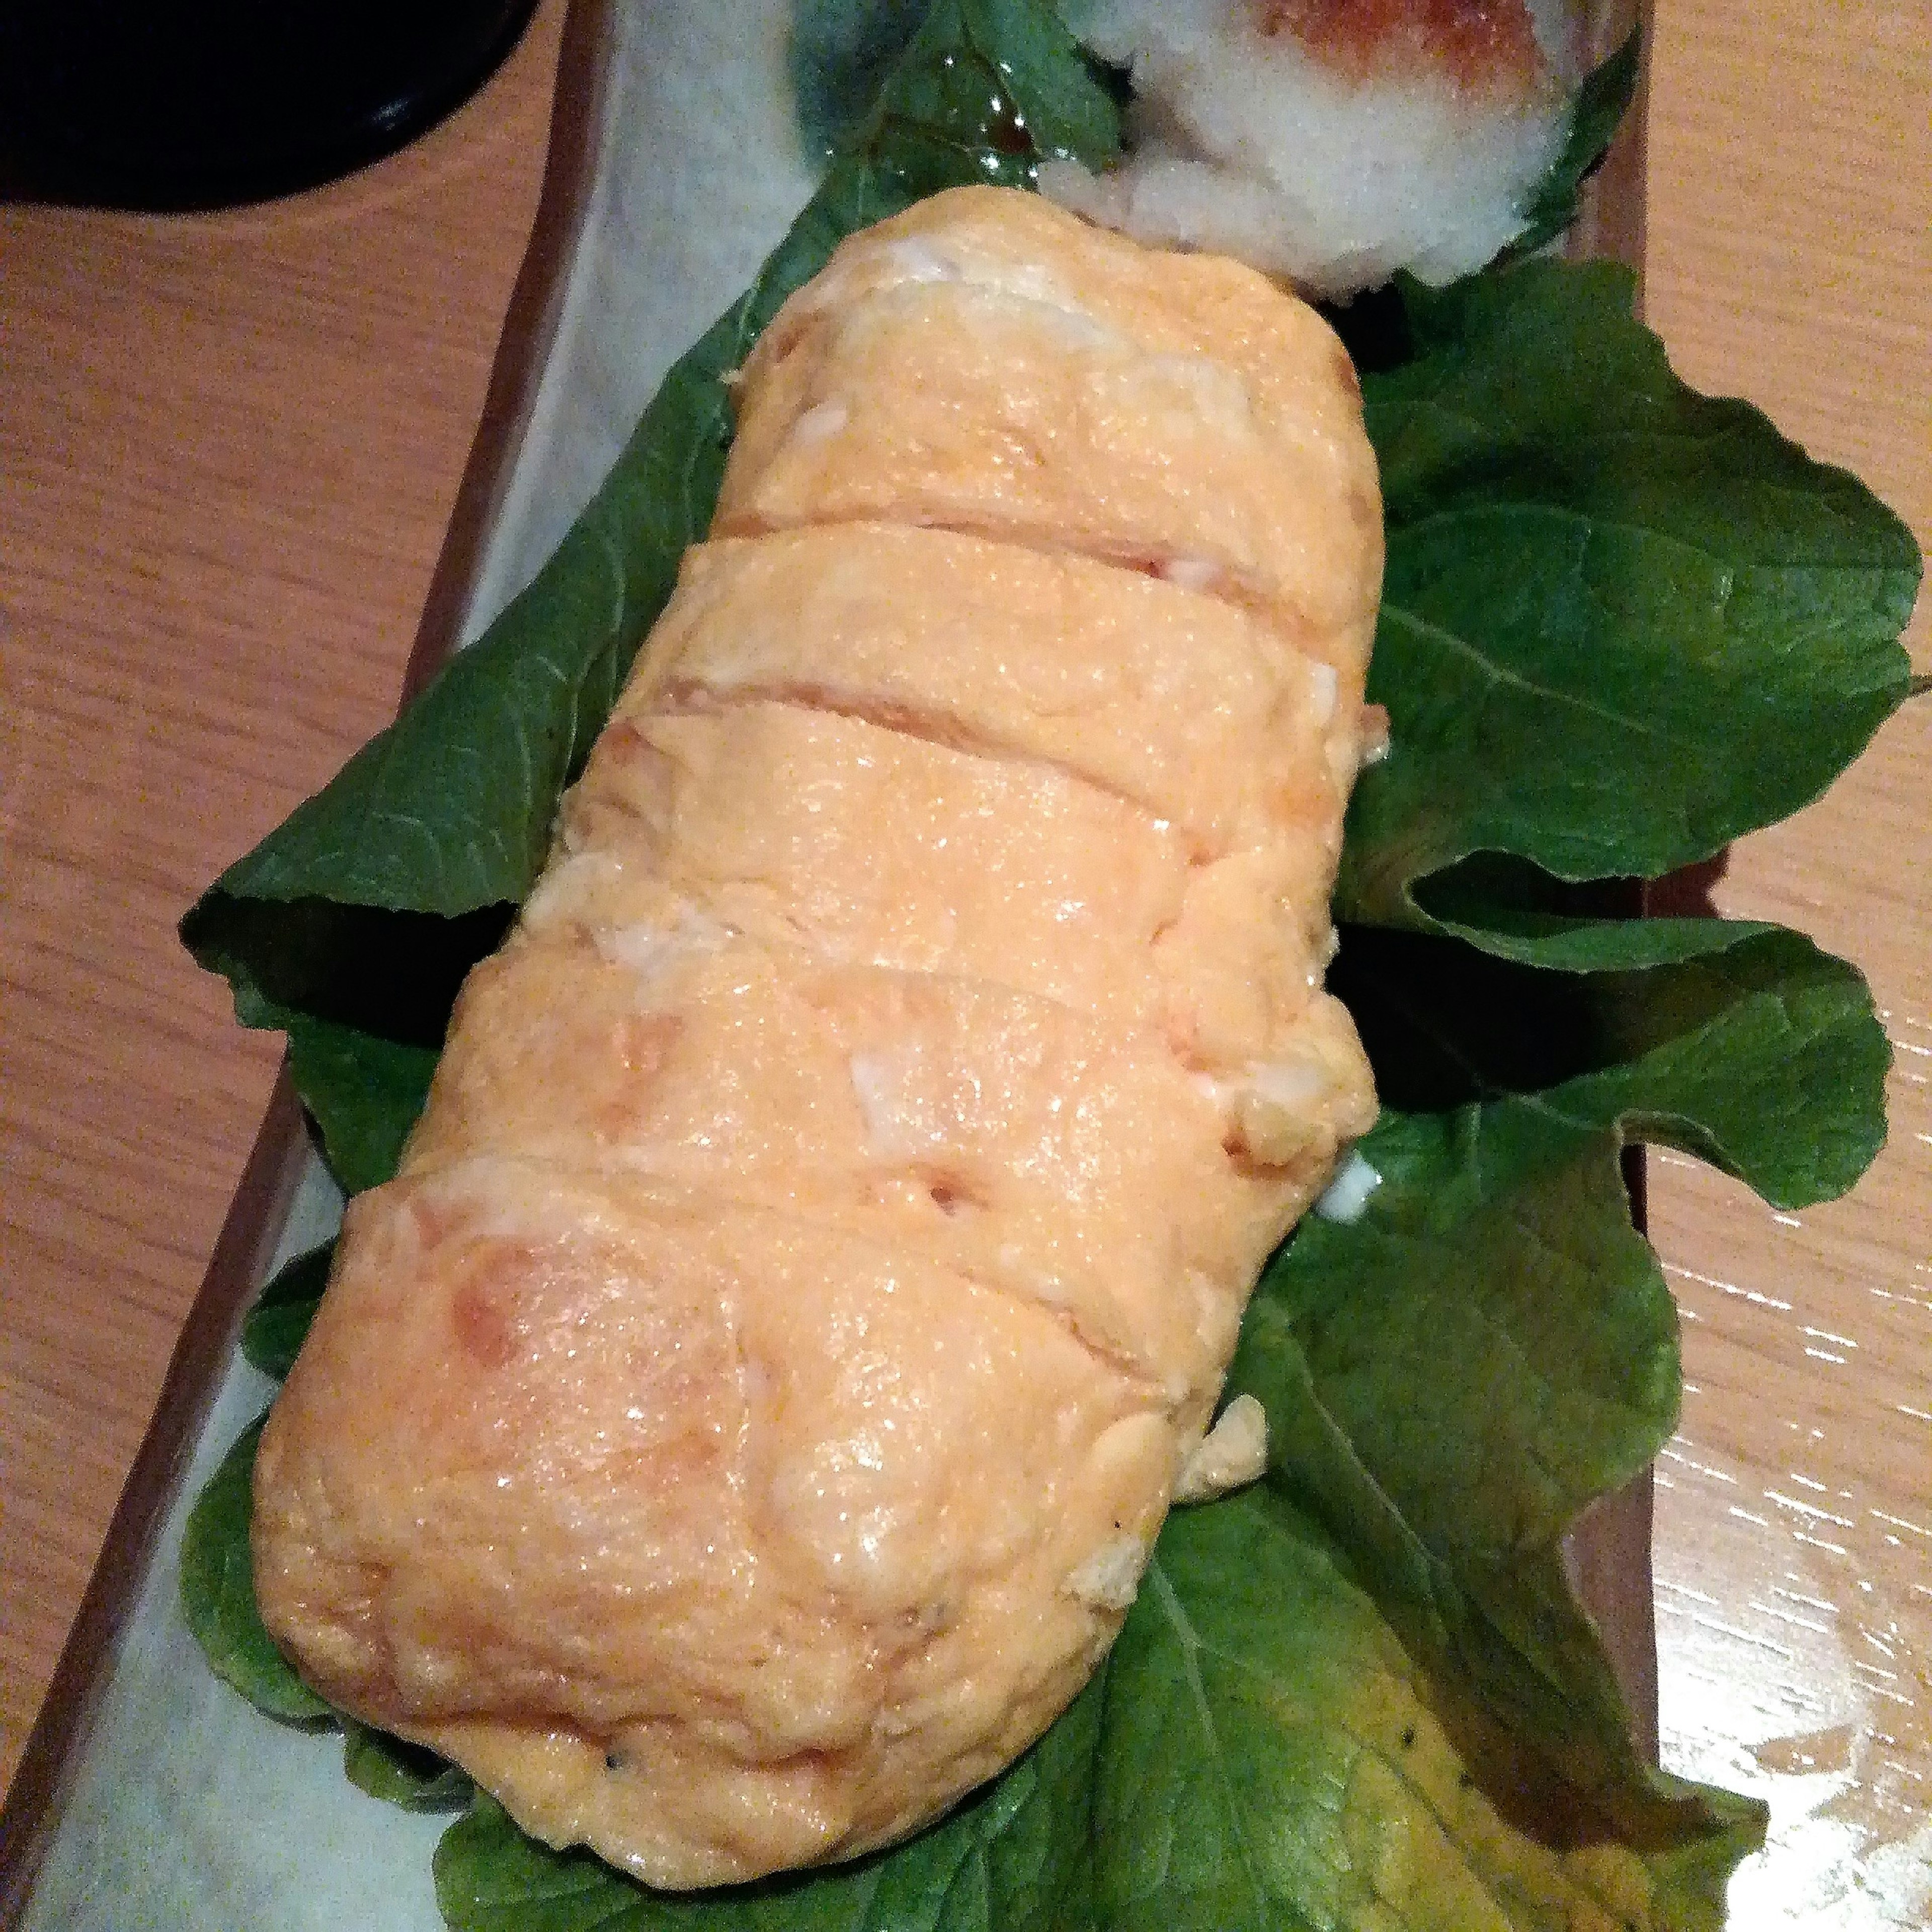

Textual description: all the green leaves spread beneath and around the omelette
[184,0,1916,1932]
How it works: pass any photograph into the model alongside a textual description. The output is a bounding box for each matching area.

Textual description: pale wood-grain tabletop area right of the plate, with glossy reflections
[1646,0,1932,1932]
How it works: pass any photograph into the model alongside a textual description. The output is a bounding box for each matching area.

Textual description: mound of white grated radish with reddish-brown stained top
[1039,0,1576,297]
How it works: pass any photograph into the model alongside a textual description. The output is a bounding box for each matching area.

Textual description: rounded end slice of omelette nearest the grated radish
[713,189,1382,664]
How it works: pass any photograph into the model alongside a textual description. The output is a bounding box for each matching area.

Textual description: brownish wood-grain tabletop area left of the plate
[0,0,562,1776]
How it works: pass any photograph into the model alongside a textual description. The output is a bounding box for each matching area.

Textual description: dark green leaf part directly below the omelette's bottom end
[437,1681,1105,1932]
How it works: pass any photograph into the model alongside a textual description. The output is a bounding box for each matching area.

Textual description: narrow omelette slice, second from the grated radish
[616,524,1362,873]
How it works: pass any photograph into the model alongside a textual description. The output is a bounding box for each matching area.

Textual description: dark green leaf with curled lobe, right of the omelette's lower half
[1231,927,1886,1835]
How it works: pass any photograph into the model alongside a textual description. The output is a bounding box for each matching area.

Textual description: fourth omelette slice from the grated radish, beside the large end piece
[404,933,1364,1431]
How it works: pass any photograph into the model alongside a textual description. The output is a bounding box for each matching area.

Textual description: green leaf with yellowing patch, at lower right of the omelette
[1095,1478,1762,1932]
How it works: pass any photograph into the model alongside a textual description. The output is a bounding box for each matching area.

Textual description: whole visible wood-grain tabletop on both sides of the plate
[0,0,1932,1932]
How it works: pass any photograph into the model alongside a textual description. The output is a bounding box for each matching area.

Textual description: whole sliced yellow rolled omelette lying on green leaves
[253,189,1380,1888]
